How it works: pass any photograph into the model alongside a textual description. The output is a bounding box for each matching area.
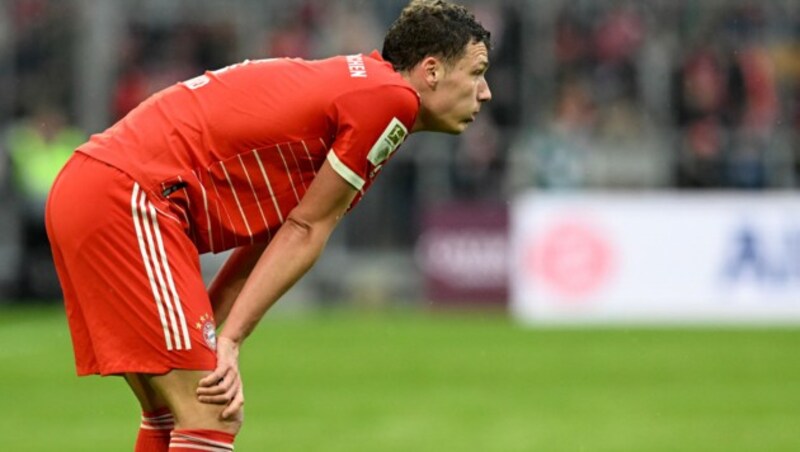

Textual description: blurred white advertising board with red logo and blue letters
[509,193,800,323]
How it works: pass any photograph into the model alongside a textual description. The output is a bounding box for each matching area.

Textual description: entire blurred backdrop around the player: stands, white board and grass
[0,0,800,452]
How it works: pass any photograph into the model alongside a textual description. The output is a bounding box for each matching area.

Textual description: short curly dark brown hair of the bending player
[382,0,491,71]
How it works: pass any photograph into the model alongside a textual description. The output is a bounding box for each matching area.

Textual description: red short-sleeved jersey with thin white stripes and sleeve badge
[78,52,419,252]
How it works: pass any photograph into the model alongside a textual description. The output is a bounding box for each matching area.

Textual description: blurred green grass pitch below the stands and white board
[0,306,800,452]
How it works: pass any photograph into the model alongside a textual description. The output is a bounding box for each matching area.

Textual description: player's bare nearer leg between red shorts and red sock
[145,370,242,435]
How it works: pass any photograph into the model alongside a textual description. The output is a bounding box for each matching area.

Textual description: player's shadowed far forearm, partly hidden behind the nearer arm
[208,244,266,325]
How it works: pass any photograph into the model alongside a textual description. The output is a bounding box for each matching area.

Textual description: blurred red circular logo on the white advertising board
[526,222,612,297]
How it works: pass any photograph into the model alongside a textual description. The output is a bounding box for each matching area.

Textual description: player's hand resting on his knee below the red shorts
[197,337,244,419]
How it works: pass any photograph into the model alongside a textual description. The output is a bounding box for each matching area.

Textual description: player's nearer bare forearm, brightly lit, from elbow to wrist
[220,218,333,343]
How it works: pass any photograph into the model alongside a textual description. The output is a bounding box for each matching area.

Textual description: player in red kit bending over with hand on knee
[46,0,491,452]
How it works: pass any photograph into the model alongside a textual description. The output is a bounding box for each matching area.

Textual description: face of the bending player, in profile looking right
[427,42,492,134]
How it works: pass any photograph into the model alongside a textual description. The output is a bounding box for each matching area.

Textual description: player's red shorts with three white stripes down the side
[46,153,216,375]
